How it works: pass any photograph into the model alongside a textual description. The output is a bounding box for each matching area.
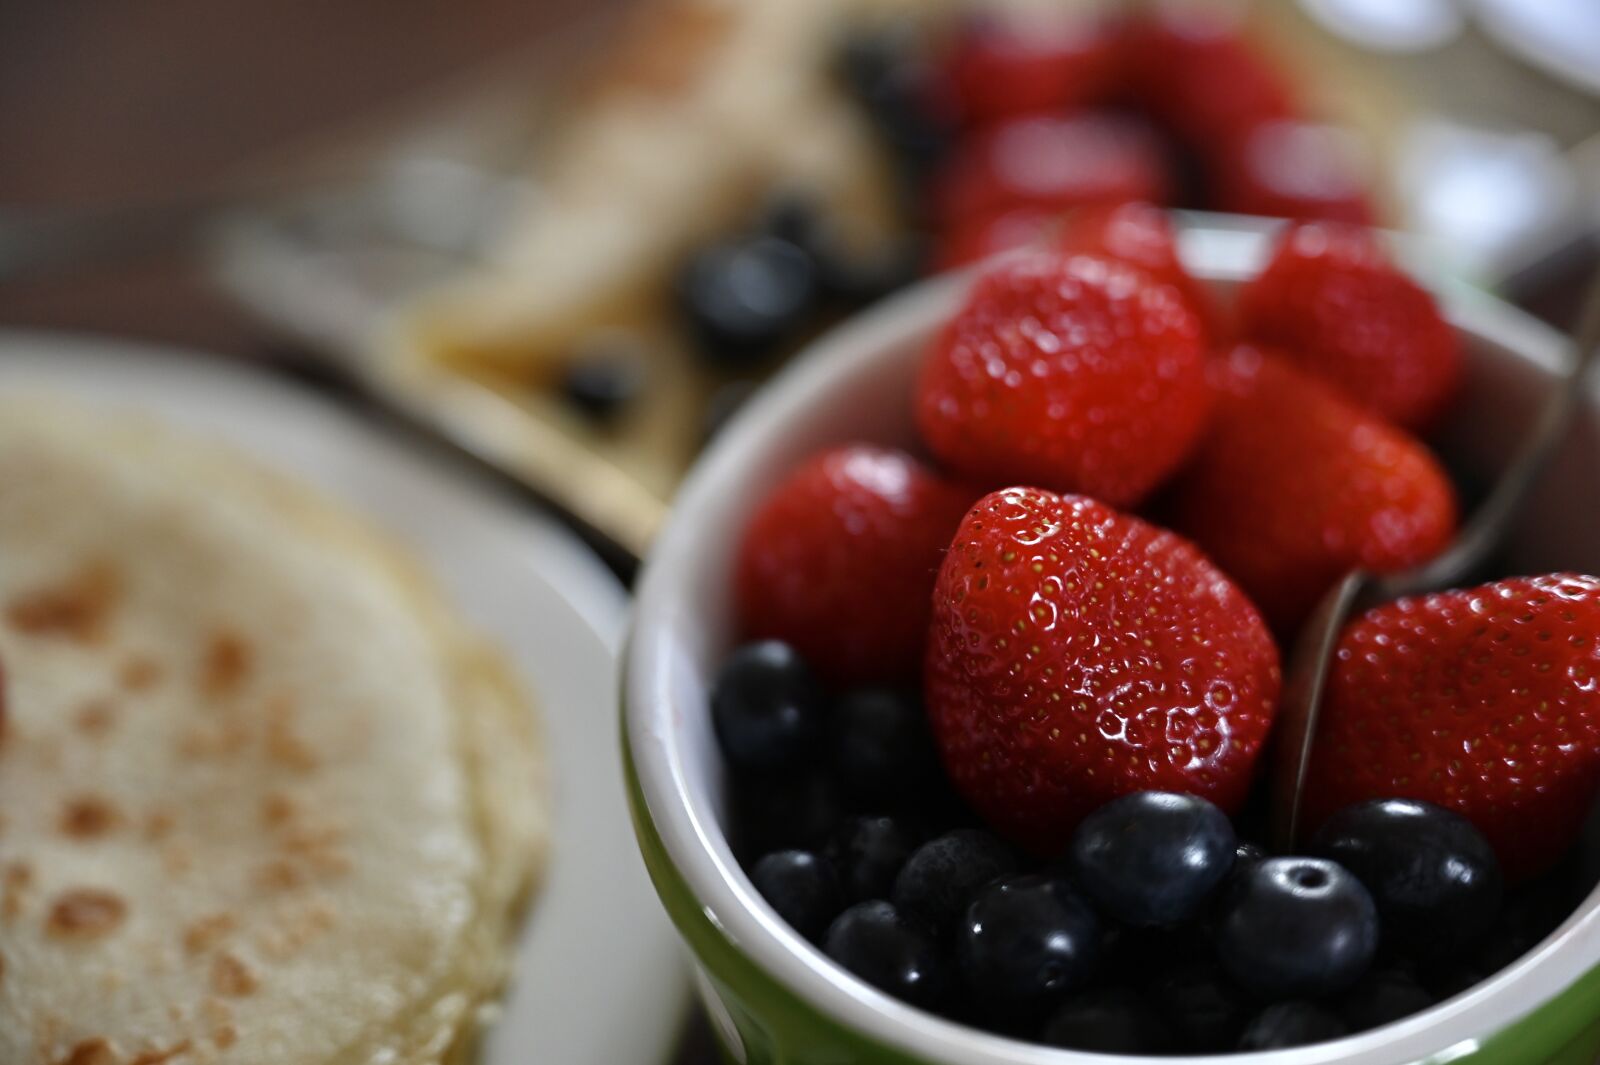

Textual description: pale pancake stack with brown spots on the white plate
[0,401,547,1065]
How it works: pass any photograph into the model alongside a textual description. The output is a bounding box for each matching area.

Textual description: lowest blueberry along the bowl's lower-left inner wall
[822,900,949,1009]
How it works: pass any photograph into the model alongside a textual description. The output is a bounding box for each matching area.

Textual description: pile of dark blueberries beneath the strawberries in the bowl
[712,641,1600,1054]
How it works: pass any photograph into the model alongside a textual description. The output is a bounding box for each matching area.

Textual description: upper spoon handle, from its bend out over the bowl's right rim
[1374,275,1600,600]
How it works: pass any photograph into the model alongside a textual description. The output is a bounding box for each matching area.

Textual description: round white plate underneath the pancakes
[0,331,688,1065]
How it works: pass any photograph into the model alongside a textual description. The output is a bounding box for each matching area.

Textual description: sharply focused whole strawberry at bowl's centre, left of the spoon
[925,488,1280,854]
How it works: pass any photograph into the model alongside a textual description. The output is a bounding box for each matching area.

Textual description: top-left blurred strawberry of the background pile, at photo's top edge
[944,13,1117,120]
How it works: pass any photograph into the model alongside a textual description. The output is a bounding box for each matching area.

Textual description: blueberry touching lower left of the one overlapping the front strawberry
[955,873,1101,1020]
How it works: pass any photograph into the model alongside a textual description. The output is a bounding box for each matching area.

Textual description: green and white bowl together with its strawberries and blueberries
[622,205,1600,1065]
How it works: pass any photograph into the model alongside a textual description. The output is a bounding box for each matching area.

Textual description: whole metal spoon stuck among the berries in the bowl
[1272,277,1600,851]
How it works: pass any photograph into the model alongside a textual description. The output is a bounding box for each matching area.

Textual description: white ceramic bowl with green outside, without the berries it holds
[624,230,1600,1065]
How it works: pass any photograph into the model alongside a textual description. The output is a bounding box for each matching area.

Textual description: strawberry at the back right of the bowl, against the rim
[1238,222,1461,427]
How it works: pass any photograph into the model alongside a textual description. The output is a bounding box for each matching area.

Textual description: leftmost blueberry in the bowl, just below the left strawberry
[710,640,824,772]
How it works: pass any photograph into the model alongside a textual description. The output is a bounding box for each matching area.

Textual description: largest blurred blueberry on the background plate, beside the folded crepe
[677,237,816,366]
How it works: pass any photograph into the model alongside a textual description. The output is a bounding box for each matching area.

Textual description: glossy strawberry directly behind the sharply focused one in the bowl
[917,251,1211,505]
